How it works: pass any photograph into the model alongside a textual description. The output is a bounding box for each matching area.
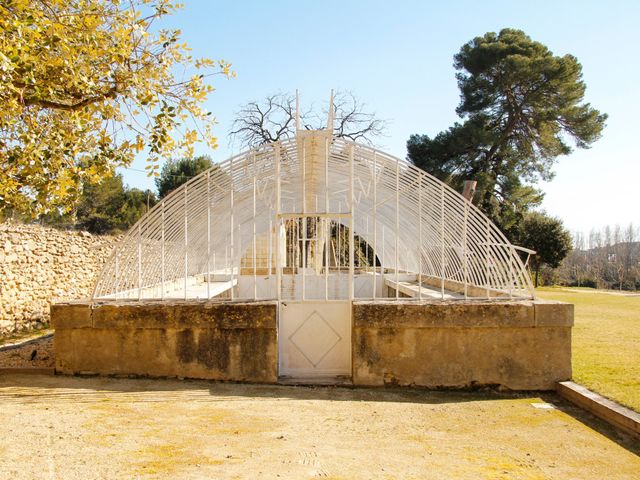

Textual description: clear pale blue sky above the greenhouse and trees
[121,0,640,231]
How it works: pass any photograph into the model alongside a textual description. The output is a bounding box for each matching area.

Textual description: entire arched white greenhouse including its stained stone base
[52,109,573,388]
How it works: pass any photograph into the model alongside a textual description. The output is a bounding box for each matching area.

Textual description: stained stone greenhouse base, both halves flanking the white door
[51,300,573,390]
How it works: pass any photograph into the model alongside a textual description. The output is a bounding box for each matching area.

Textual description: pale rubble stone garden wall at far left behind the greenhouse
[0,223,117,333]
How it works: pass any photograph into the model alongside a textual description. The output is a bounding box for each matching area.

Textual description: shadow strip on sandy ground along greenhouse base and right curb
[0,375,640,455]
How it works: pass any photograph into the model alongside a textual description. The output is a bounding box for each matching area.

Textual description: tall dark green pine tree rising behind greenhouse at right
[407,29,607,236]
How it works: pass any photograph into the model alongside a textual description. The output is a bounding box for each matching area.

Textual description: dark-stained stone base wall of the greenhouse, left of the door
[51,301,278,383]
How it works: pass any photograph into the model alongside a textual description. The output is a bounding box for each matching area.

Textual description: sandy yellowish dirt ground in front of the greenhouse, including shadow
[0,375,640,480]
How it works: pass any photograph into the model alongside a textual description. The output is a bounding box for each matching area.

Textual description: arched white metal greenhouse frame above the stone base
[93,130,533,301]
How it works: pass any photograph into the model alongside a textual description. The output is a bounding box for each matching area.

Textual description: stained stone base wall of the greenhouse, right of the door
[353,301,573,390]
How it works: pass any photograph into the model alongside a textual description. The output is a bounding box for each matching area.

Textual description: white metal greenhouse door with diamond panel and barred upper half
[277,214,353,383]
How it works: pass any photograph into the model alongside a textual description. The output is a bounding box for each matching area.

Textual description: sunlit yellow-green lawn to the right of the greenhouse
[537,288,640,412]
